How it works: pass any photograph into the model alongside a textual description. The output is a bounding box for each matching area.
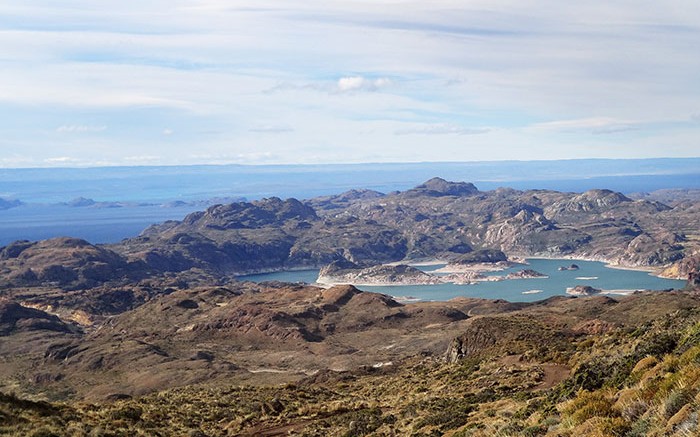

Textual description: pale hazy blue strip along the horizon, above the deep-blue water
[0,158,700,203]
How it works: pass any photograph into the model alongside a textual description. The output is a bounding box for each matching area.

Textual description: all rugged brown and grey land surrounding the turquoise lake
[0,179,700,436]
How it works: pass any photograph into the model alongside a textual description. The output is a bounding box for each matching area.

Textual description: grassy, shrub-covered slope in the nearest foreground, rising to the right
[0,292,700,436]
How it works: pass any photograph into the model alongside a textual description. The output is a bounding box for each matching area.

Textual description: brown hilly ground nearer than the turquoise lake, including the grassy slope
[0,284,700,436]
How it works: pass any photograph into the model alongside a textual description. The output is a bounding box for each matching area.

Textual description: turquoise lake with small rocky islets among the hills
[239,259,685,302]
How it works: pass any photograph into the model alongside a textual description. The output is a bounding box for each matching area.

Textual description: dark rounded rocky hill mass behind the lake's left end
[121,198,407,274]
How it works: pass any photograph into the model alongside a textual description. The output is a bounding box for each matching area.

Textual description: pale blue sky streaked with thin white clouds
[0,0,700,168]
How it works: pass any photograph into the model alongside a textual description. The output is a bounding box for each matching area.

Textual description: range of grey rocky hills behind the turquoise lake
[85,178,700,282]
